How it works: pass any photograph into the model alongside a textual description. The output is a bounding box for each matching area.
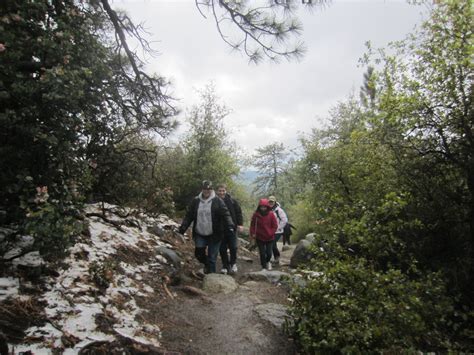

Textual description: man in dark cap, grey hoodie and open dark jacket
[178,180,234,274]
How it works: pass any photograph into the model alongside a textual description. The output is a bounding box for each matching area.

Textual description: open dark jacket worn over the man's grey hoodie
[179,196,235,241]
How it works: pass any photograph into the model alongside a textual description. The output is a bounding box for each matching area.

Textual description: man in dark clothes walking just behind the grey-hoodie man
[217,184,244,274]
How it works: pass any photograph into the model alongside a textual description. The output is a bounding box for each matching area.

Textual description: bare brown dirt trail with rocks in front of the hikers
[156,243,295,355]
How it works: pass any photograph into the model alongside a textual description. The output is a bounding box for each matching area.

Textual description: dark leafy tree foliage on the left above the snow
[0,0,175,239]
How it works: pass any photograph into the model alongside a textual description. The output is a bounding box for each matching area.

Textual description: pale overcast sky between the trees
[112,0,424,154]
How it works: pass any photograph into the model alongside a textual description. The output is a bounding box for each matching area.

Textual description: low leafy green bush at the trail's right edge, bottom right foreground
[287,251,453,354]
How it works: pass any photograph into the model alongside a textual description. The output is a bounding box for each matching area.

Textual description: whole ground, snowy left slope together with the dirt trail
[0,205,295,355]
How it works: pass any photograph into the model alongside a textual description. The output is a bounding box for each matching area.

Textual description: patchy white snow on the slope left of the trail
[7,205,178,354]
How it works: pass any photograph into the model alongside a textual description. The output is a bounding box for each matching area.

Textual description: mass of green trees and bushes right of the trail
[291,1,474,353]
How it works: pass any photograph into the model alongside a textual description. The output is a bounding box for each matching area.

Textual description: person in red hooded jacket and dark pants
[250,198,278,270]
